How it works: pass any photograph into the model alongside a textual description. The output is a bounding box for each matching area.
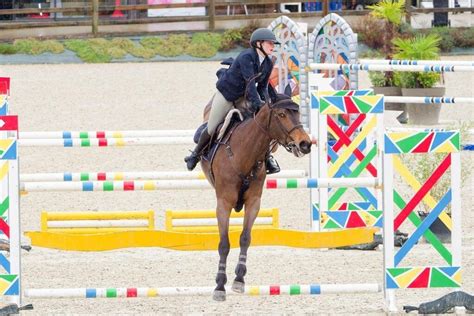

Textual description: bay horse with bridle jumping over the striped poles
[201,94,311,301]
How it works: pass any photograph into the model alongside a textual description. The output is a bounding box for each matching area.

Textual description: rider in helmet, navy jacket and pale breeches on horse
[184,28,280,174]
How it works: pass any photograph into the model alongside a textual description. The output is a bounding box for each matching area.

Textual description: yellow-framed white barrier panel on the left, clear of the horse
[41,210,155,234]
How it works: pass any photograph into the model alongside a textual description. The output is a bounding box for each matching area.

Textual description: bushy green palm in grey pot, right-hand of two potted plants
[393,34,446,125]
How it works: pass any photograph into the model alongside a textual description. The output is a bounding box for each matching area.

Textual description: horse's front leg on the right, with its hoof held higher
[232,197,260,293]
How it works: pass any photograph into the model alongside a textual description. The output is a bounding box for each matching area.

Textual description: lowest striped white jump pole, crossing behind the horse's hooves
[24,283,382,298]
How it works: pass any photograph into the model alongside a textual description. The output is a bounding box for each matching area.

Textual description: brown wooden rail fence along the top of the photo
[0,0,474,35]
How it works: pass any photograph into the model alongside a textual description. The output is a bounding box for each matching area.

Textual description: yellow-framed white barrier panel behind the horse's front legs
[165,208,279,233]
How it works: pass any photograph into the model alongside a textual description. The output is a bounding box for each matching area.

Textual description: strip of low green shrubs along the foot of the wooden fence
[0,22,474,63]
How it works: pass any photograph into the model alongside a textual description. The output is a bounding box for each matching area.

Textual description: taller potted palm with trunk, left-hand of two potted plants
[366,0,407,123]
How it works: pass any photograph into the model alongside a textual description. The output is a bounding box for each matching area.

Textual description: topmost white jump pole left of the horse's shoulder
[19,129,195,139]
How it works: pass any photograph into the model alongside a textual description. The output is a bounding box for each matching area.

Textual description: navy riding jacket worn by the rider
[216,48,276,104]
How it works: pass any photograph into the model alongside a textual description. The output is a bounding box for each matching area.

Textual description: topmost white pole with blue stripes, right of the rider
[309,63,474,72]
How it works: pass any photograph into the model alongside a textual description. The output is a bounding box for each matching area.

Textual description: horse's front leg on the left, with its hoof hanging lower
[213,199,232,301]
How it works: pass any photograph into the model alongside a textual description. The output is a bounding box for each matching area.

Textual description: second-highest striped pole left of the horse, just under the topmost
[18,137,194,147]
